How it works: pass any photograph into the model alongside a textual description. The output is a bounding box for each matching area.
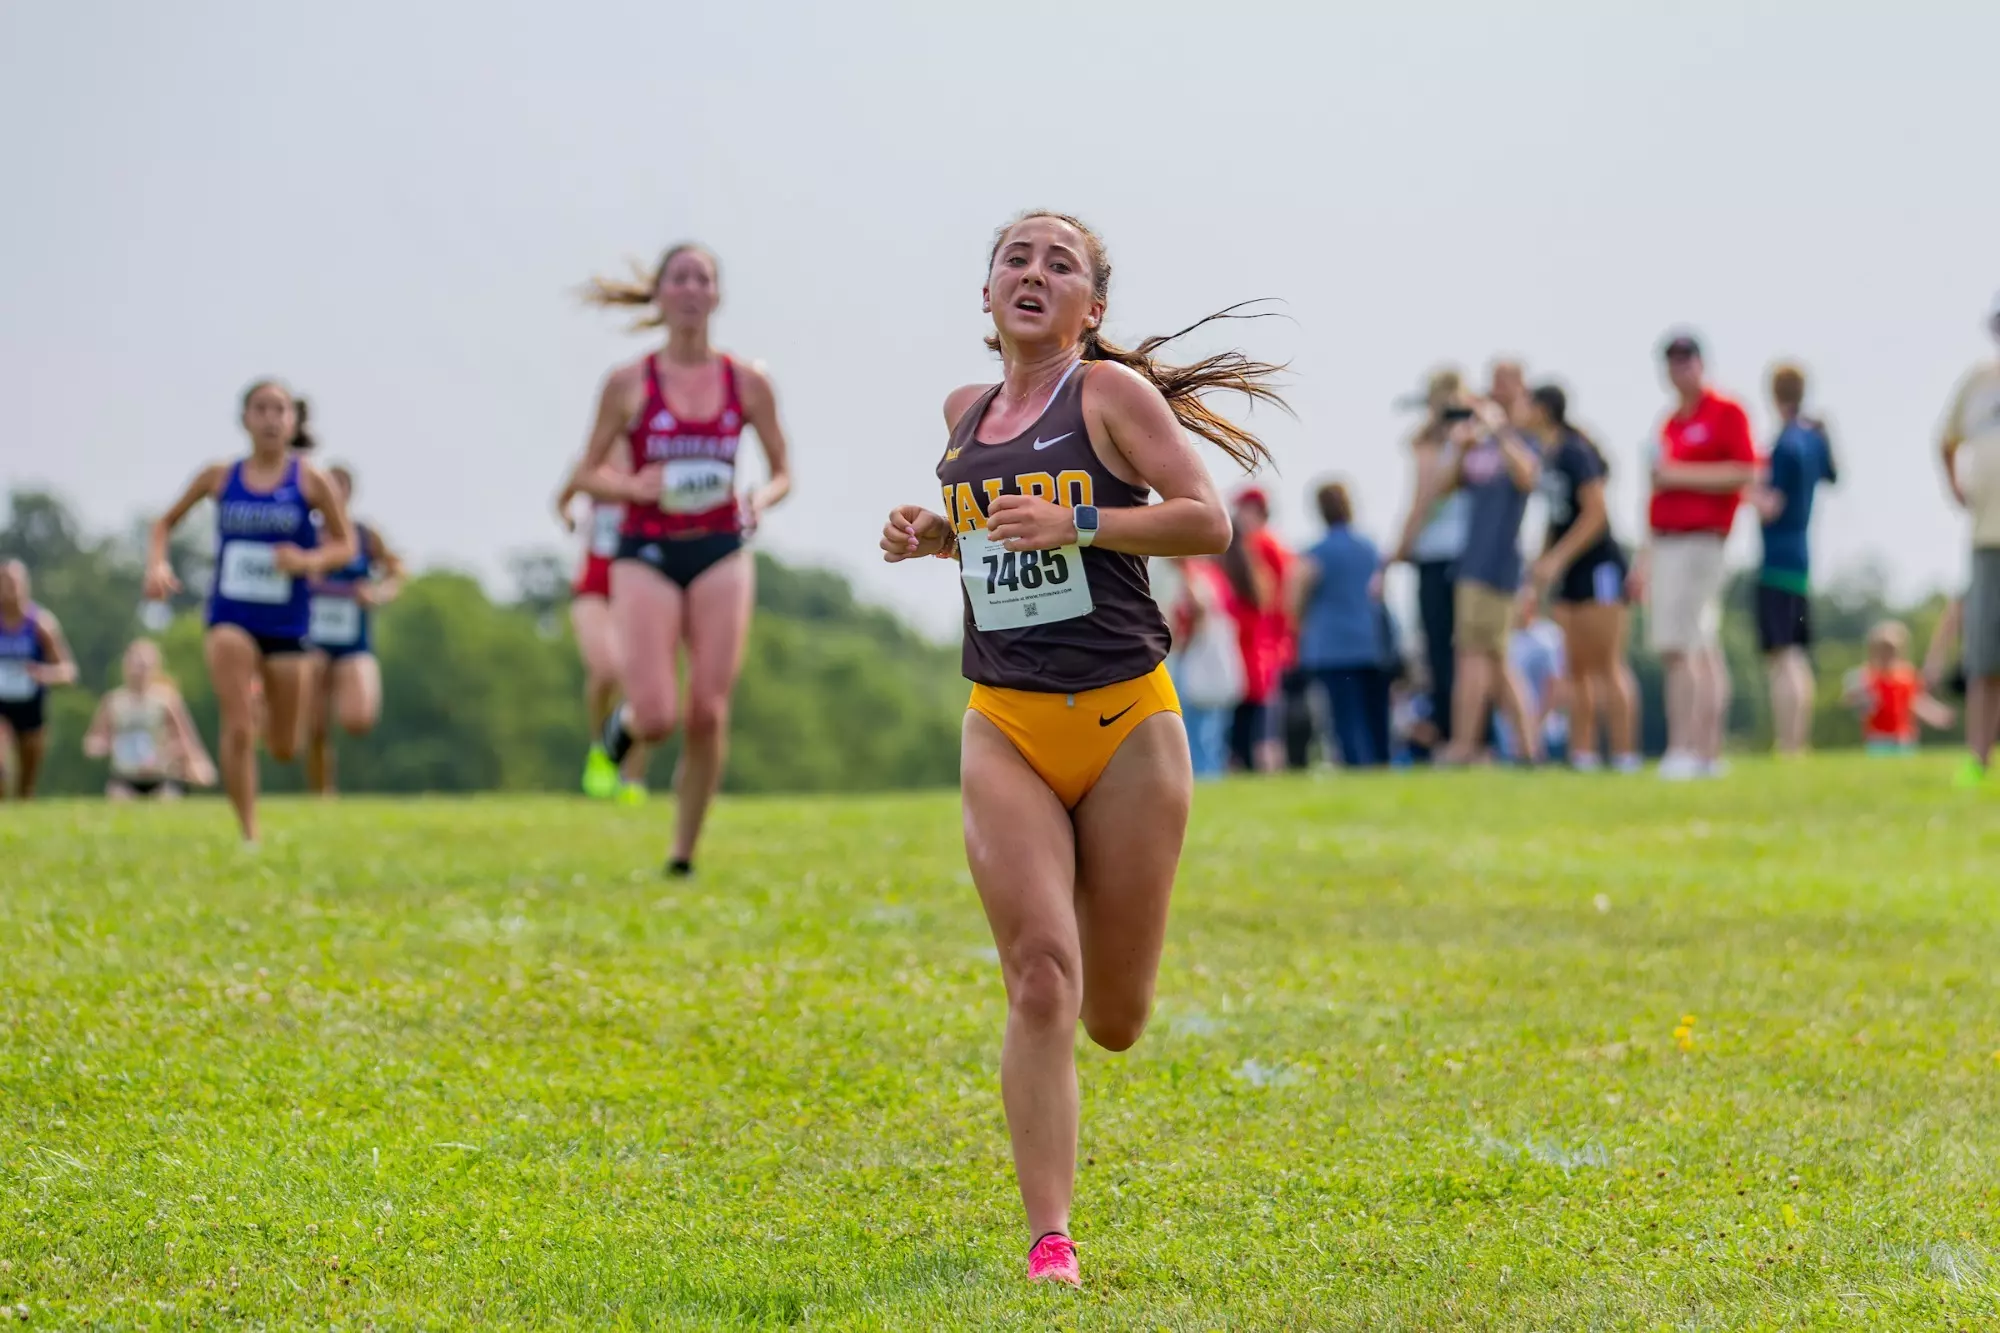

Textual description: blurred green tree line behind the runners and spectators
[0,490,1942,795]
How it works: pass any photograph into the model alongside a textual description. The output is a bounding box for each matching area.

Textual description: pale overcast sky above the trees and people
[0,0,2000,628]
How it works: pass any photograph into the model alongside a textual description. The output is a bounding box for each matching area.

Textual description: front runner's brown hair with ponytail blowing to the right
[988,208,1292,472]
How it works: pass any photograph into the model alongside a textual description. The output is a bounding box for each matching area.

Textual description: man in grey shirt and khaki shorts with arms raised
[1396,382,1542,765]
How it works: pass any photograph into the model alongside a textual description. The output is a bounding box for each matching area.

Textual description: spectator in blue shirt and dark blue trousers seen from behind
[1290,482,1388,769]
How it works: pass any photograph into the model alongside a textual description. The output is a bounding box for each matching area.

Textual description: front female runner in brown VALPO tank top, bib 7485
[882,212,1282,1283]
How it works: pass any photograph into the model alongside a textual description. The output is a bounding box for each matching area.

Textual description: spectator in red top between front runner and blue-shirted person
[1222,486,1294,773]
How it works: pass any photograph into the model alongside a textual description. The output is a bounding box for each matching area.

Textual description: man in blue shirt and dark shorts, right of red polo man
[1750,366,1838,755]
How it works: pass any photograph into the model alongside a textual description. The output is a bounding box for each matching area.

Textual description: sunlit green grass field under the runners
[0,759,2000,1329]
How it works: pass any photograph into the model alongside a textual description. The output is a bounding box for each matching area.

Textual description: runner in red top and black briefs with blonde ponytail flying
[570,244,792,875]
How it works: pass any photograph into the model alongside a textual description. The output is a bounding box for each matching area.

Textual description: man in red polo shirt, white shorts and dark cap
[1632,334,1756,781]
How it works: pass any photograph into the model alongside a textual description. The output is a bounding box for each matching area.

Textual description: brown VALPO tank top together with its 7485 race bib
[938,362,1168,695]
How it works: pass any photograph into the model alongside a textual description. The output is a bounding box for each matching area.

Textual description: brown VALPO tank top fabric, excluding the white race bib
[938,362,1168,695]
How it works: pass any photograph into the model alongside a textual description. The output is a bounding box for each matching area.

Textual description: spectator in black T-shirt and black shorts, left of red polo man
[1528,384,1640,773]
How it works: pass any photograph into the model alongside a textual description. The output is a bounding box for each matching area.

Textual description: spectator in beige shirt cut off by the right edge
[1938,296,2000,787]
